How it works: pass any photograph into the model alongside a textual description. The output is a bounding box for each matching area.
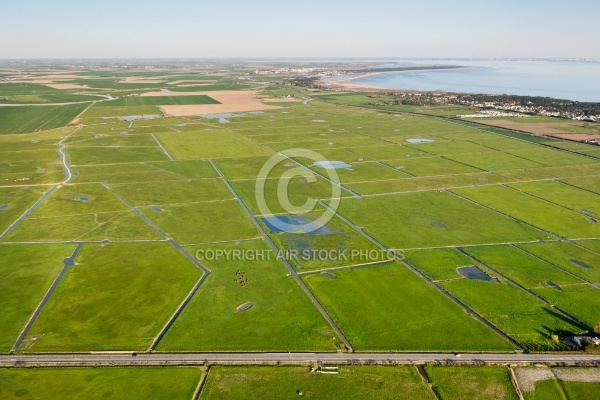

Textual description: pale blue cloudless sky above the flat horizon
[0,0,600,59]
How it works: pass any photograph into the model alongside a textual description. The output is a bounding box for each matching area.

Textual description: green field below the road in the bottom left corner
[0,367,202,400]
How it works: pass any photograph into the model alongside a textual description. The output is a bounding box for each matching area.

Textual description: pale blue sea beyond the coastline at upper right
[352,59,600,102]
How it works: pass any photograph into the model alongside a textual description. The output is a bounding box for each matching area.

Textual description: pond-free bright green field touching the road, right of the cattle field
[302,263,512,351]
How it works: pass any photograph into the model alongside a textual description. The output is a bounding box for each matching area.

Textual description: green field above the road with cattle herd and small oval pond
[158,240,339,351]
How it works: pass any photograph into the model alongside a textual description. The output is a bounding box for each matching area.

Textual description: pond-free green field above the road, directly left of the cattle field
[23,243,202,352]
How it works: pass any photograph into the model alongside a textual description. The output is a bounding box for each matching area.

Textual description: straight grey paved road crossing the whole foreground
[0,353,600,365]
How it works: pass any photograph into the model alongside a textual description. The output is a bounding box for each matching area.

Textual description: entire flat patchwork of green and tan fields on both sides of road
[0,73,600,370]
